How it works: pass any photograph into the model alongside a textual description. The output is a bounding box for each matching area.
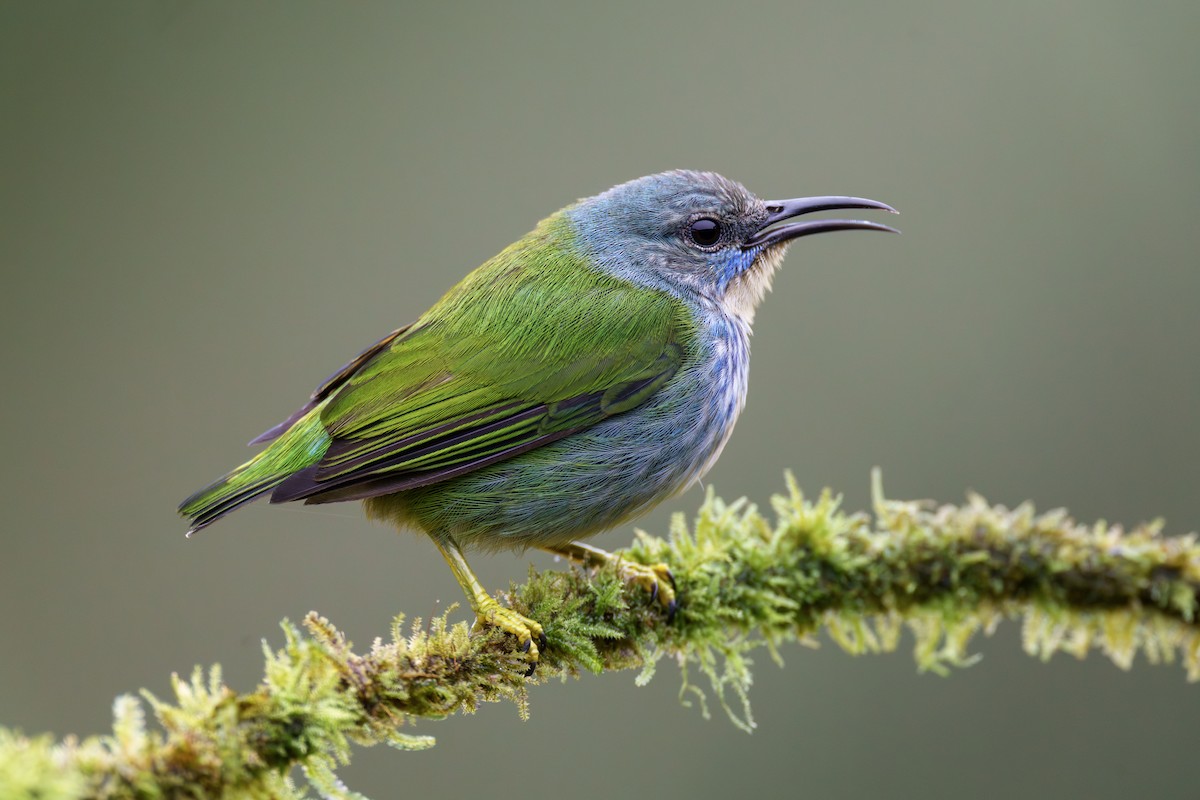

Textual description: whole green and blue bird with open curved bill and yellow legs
[179,170,898,673]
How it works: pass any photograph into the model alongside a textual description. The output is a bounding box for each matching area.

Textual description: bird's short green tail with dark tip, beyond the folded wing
[179,405,329,535]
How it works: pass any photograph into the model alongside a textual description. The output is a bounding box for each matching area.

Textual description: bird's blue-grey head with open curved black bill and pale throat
[566,170,896,323]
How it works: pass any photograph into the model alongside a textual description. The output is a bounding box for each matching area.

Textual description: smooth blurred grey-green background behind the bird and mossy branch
[0,0,1200,799]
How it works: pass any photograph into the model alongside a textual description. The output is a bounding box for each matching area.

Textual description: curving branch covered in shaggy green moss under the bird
[0,474,1200,800]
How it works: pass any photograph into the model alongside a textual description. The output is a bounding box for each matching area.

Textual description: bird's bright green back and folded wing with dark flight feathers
[271,225,694,503]
